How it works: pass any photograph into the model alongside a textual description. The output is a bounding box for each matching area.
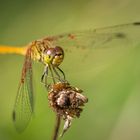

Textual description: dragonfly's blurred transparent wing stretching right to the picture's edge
[45,22,140,51]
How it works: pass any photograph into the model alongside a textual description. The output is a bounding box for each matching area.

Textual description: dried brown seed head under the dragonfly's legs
[48,82,88,136]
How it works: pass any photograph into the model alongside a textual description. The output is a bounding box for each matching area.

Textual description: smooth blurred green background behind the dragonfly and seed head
[0,0,140,140]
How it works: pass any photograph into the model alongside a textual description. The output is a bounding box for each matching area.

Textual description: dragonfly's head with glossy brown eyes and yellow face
[43,46,64,66]
